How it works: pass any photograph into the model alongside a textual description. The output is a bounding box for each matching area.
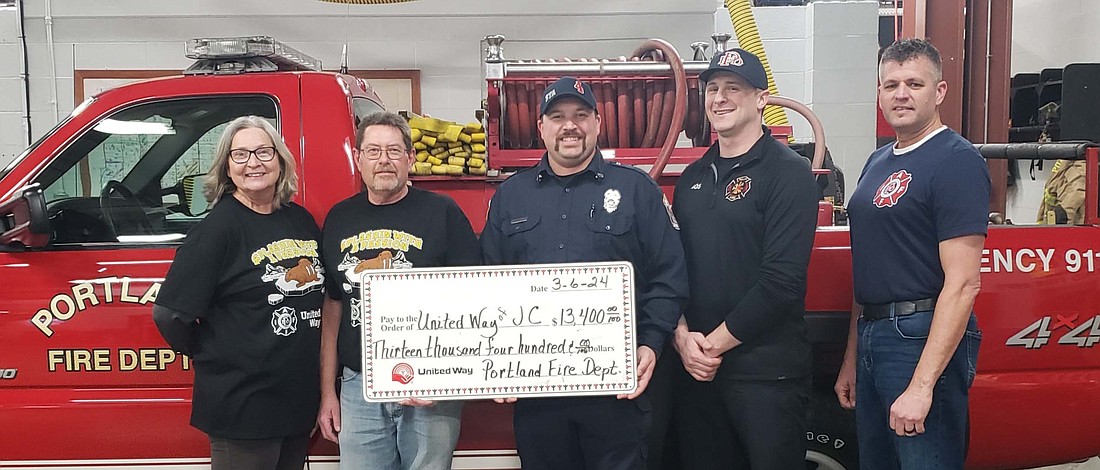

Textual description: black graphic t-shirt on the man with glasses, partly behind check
[321,187,481,371]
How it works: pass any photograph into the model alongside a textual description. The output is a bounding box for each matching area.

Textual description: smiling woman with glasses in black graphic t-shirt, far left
[153,116,325,470]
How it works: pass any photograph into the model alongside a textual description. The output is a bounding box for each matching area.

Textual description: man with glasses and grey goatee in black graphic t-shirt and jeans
[317,112,481,470]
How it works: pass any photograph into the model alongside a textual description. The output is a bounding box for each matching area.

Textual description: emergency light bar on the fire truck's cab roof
[187,36,321,73]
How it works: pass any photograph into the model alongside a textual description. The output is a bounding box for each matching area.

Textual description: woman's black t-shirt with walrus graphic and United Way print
[156,196,326,439]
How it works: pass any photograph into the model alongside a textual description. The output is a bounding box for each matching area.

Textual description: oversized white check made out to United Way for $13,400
[360,262,637,402]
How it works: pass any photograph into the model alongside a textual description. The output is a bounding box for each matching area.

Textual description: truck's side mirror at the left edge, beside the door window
[0,183,50,251]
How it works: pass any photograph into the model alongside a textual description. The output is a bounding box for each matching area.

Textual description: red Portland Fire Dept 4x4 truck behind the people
[0,39,1100,469]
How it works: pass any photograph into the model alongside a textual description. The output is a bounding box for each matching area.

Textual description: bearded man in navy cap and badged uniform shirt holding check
[481,77,688,470]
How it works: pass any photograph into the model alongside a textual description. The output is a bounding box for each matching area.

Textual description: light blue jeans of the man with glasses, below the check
[340,368,462,470]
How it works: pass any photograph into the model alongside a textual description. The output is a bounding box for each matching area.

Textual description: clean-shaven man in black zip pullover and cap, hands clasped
[673,48,818,470]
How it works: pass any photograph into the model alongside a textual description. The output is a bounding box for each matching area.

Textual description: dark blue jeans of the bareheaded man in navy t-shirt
[856,311,981,470]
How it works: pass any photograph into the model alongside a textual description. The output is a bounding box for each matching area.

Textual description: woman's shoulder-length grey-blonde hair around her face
[204,116,298,210]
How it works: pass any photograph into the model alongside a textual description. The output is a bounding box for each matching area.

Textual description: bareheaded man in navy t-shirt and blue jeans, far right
[836,40,990,470]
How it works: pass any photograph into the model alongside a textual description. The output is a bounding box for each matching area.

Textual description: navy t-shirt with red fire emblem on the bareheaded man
[848,127,990,305]
